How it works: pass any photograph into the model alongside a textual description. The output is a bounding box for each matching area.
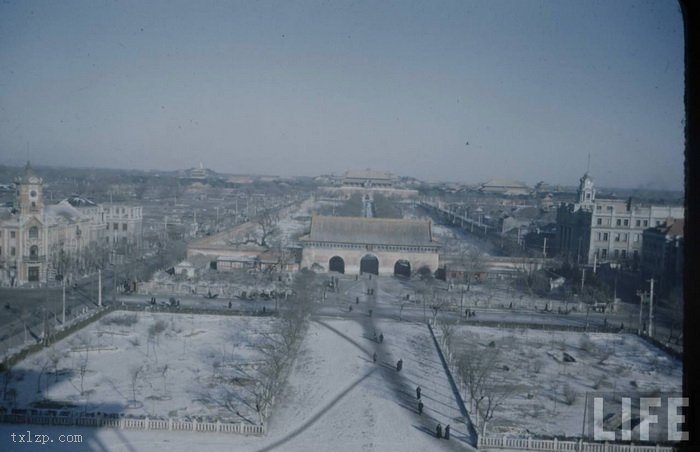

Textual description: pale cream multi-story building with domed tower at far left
[0,163,142,286]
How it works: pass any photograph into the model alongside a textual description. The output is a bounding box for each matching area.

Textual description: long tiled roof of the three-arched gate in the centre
[301,215,438,246]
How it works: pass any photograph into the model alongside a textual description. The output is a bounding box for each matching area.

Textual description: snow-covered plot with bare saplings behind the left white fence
[8,312,274,423]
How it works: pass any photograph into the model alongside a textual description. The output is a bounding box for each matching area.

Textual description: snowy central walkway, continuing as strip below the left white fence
[0,320,471,452]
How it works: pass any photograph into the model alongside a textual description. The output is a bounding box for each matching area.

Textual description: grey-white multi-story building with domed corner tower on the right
[557,173,684,267]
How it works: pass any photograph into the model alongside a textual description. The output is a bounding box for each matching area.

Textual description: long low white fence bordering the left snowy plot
[0,414,265,436]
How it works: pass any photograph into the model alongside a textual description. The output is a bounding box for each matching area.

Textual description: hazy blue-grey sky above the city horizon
[0,0,684,188]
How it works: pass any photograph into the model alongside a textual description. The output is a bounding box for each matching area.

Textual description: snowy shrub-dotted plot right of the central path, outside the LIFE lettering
[446,326,683,436]
